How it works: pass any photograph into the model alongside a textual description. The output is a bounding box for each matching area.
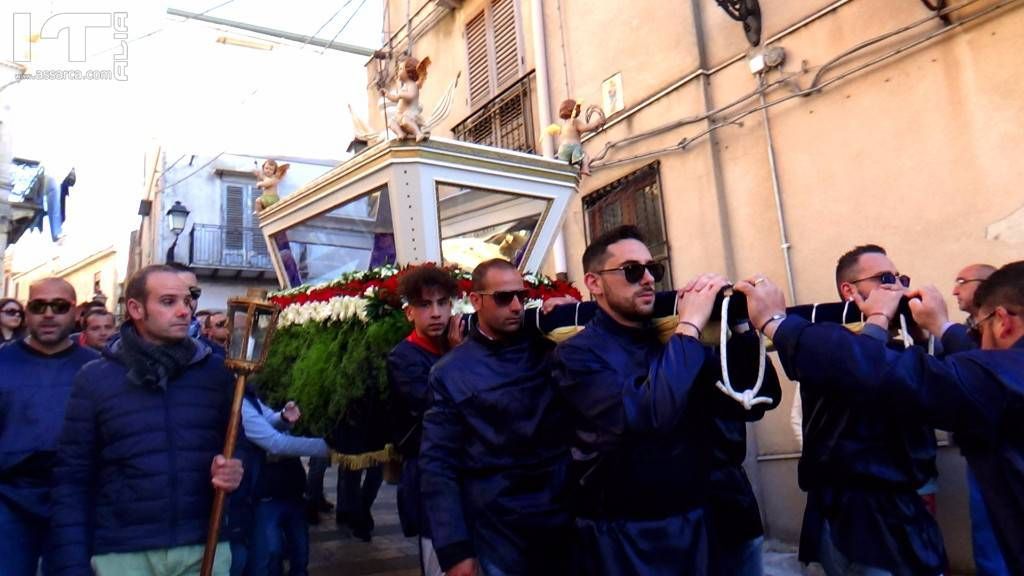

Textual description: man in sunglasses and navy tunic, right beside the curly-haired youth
[420,259,570,576]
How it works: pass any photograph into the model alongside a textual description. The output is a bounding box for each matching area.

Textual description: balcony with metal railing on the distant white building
[188,224,273,279]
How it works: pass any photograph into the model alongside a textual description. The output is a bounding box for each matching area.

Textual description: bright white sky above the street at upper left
[0,0,383,270]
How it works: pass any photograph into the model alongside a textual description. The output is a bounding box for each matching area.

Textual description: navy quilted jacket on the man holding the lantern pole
[50,334,233,575]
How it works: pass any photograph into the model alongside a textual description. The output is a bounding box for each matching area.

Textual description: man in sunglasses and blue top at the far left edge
[0,278,98,576]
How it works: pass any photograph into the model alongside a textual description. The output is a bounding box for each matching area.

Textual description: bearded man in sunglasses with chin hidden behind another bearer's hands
[791,244,946,576]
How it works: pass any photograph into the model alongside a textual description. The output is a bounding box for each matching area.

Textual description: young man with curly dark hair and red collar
[387,265,462,576]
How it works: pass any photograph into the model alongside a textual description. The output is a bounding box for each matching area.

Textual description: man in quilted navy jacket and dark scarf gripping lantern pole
[51,265,242,576]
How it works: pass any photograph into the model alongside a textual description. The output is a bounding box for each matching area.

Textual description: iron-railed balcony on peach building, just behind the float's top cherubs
[452,73,537,154]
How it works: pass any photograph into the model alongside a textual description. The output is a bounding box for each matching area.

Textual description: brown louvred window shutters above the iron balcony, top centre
[466,0,523,108]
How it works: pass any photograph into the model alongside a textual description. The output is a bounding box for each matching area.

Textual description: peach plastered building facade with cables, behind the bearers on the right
[367,0,1024,572]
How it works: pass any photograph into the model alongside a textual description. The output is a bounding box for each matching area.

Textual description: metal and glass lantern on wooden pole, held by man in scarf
[200,292,281,576]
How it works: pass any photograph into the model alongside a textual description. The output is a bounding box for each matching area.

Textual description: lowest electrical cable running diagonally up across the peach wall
[591,0,1020,170]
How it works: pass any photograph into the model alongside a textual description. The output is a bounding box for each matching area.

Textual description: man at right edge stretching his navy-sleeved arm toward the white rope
[737,261,1024,574]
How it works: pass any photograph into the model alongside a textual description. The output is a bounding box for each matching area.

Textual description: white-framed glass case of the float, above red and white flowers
[252,137,577,287]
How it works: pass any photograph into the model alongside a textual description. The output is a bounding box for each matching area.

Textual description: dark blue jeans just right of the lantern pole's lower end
[247,499,309,576]
